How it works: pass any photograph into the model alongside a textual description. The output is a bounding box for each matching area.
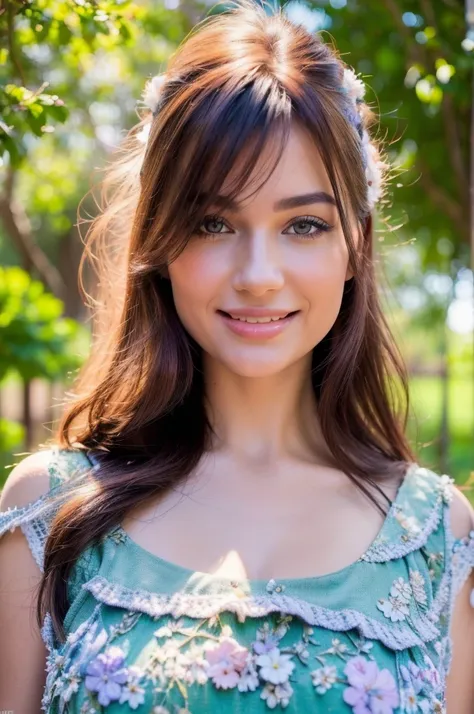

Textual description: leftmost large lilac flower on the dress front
[85,647,128,707]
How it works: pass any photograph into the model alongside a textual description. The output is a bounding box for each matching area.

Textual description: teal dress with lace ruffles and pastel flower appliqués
[0,448,474,714]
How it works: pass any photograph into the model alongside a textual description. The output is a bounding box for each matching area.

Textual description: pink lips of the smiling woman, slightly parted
[217,307,299,338]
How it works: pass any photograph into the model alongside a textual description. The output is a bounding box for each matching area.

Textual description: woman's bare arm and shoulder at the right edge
[447,489,474,714]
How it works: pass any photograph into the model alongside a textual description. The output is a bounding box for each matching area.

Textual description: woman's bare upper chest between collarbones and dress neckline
[122,461,396,579]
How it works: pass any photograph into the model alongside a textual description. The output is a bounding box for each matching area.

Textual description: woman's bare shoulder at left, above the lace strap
[0,449,52,511]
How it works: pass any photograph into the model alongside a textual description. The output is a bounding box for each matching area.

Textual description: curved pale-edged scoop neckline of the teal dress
[103,462,420,594]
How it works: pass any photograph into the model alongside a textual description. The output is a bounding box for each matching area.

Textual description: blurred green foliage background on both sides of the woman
[0,0,474,490]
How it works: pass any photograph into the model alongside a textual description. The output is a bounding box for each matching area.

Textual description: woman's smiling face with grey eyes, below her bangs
[168,125,352,377]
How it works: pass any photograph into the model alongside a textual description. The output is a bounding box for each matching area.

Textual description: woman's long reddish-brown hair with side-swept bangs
[37,0,414,639]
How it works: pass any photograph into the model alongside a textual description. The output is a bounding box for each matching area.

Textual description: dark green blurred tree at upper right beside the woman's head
[283,0,474,269]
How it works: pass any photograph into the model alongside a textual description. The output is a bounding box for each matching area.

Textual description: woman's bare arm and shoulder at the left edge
[0,451,54,714]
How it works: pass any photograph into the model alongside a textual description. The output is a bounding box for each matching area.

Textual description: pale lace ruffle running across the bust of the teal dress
[82,575,439,650]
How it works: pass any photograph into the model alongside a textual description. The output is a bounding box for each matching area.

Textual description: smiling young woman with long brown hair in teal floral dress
[0,0,474,714]
